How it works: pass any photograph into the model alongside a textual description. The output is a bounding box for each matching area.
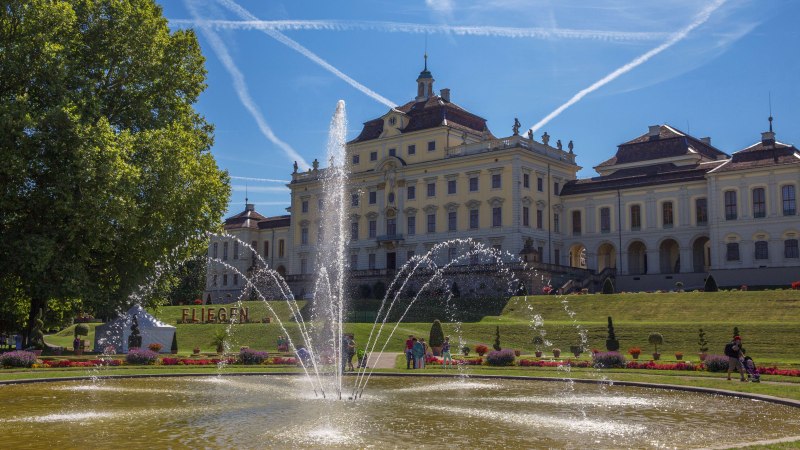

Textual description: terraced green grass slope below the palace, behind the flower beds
[42,290,800,365]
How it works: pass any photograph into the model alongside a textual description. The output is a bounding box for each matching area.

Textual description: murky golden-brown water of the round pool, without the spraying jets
[0,376,800,448]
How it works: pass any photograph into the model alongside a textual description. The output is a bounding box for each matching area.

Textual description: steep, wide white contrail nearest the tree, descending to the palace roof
[184,0,310,170]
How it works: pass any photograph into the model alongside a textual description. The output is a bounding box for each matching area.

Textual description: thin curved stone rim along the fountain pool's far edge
[0,372,800,408]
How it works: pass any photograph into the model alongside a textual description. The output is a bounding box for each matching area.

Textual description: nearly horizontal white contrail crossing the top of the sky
[169,19,669,41]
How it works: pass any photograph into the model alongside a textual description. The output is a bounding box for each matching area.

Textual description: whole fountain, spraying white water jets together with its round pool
[0,101,800,448]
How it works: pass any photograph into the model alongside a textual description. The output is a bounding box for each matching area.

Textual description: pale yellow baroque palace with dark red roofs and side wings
[203,62,800,303]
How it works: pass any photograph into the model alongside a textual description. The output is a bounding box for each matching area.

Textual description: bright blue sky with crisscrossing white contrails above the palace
[160,0,800,215]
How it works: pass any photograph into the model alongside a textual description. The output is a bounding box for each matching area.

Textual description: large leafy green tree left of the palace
[0,0,230,344]
